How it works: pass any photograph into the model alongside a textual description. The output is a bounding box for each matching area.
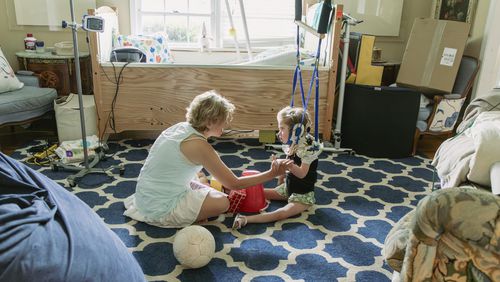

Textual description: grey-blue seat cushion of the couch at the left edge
[0,86,57,124]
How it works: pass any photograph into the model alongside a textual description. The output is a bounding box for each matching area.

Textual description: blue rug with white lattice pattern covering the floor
[12,139,433,281]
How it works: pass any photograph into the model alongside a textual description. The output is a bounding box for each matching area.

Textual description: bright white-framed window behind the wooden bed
[130,0,296,48]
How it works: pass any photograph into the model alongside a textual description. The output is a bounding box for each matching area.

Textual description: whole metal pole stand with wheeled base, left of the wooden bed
[52,0,124,187]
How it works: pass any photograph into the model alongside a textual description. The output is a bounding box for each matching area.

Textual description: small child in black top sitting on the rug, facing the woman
[233,107,318,229]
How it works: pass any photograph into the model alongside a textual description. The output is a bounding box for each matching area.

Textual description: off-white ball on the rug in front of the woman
[174,225,215,268]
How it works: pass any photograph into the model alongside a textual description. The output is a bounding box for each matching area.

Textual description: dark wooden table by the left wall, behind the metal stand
[16,51,92,96]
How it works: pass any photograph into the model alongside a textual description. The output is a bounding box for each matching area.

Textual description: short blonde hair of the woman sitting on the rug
[186,90,234,132]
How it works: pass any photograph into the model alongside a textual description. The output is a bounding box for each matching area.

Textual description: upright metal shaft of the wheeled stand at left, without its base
[69,0,89,169]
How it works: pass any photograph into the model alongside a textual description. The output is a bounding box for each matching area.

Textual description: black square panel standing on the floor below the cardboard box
[341,84,420,158]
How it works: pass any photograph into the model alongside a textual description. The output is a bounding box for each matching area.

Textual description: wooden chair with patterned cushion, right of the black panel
[413,56,479,154]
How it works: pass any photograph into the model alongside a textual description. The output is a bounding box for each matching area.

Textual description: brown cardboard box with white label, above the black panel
[396,19,470,94]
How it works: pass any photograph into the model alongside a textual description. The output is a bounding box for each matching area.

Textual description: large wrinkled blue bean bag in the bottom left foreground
[0,153,145,282]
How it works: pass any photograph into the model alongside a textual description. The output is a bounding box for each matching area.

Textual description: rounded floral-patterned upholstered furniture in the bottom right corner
[383,188,500,281]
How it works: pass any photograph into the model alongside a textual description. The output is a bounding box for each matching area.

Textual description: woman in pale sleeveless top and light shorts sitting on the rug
[124,91,284,227]
